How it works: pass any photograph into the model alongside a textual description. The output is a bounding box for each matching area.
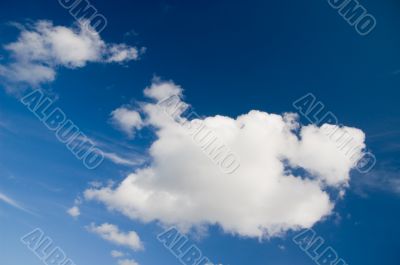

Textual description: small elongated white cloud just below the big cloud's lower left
[87,223,143,251]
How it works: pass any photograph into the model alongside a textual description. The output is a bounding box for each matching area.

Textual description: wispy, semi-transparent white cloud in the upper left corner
[0,20,143,86]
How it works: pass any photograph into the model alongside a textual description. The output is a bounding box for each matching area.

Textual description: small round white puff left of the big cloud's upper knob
[111,107,143,137]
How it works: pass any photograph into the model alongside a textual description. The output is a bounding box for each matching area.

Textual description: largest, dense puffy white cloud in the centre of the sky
[85,80,365,237]
